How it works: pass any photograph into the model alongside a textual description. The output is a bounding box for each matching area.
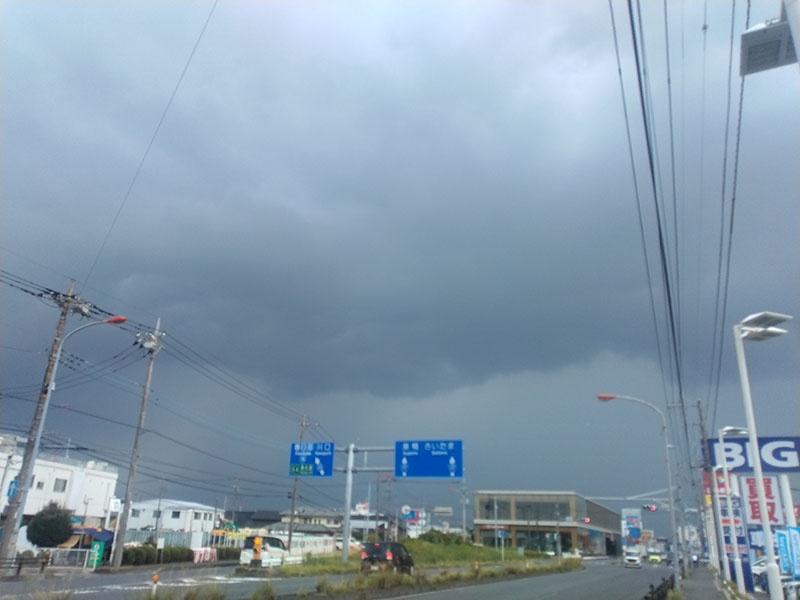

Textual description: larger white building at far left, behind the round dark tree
[0,435,118,526]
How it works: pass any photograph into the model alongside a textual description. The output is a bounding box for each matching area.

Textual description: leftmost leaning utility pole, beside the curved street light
[0,280,89,559]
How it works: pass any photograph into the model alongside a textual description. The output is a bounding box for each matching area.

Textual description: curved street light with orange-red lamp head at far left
[0,312,126,559]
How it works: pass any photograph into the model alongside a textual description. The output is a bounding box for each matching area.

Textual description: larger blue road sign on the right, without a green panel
[394,440,464,478]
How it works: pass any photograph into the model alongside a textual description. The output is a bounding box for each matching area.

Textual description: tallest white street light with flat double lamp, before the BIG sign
[733,312,792,600]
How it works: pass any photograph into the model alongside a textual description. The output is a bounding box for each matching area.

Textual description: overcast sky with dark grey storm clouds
[0,0,800,536]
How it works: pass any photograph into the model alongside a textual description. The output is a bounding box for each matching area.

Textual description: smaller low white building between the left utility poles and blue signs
[128,498,225,532]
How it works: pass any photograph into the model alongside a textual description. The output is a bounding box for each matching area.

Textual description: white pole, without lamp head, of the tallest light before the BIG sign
[733,323,783,600]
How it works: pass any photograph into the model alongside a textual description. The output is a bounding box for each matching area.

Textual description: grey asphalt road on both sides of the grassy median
[0,561,670,600]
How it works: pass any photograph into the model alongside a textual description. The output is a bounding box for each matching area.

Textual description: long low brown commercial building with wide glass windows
[473,490,622,556]
